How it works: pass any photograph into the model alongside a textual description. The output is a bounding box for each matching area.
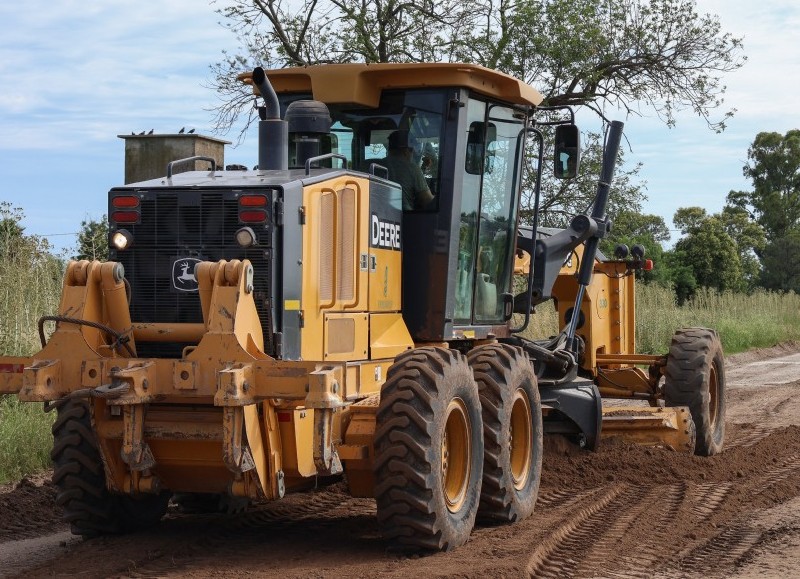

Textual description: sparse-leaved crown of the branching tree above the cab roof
[212,0,745,130]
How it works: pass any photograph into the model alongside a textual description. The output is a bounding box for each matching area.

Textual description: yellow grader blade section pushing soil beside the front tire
[601,406,696,452]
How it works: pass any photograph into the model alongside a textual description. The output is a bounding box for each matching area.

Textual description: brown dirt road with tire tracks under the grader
[0,345,800,578]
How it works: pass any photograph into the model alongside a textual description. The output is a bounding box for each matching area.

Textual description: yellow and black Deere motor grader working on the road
[0,64,725,550]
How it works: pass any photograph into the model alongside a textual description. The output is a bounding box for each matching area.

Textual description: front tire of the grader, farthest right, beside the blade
[664,328,725,456]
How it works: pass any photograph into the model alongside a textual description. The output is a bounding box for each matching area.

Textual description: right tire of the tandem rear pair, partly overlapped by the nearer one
[468,344,544,523]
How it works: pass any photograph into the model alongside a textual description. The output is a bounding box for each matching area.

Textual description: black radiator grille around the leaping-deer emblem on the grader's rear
[116,190,275,357]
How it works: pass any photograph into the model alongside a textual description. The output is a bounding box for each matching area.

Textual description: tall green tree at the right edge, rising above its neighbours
[728,129,800,242]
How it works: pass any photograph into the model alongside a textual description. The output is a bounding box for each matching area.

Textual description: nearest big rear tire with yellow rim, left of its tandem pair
[374,348,483,551]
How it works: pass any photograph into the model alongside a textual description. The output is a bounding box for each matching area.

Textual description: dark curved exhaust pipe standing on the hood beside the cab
[253,66,289,171]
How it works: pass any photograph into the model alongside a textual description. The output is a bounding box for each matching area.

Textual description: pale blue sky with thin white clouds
[0,0,800,252]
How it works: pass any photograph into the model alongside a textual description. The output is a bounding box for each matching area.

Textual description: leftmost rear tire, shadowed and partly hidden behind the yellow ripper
[50,400,170,538]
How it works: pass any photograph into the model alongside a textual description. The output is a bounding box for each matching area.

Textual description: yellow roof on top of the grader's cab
[238,62,544,107]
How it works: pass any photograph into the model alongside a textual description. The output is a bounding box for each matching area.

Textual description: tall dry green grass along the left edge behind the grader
[0,227,63,483]
